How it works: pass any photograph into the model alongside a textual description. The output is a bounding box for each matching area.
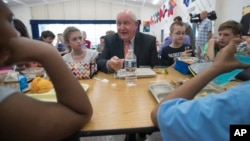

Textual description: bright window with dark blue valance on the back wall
[30,20,117,47]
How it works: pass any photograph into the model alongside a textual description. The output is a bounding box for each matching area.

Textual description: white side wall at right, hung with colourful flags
[151,0,250,39]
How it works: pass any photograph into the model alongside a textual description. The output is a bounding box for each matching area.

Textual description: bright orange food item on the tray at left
[30,77,52,93]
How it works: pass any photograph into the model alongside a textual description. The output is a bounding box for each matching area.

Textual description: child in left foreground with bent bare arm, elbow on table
[0,0,92,141]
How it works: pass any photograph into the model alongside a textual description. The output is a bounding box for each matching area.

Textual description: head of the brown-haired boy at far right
[218,20,241,47]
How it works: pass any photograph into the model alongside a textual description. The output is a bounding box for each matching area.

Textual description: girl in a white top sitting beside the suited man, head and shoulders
[63,27,98,63]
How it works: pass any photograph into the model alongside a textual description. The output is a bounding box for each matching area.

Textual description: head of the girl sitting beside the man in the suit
[63,26,83,51]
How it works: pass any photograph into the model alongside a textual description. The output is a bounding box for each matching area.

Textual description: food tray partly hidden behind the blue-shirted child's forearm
[148,82,221,103]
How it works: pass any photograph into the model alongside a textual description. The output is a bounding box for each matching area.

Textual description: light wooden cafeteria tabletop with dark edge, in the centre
[80,69,192,135]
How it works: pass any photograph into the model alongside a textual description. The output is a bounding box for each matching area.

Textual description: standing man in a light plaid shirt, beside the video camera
[195,10,212,59]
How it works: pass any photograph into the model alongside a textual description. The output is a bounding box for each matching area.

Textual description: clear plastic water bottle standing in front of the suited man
[124,49,137,87]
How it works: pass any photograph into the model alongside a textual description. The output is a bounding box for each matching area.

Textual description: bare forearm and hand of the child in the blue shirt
[151,39,250,126]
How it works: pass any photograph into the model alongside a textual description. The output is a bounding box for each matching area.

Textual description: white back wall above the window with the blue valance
[10,0,156,37]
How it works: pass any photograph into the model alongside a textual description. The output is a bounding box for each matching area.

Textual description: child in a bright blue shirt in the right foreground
[151,38,250,141]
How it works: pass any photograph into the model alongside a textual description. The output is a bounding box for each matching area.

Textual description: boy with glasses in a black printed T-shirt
[161,22,194,66]
